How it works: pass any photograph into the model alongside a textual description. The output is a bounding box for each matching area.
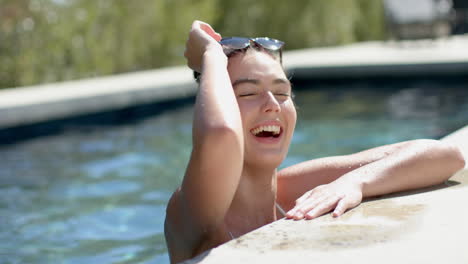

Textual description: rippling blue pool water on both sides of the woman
[0,80,468,263]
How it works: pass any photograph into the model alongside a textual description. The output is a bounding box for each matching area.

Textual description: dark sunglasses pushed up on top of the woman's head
[219,37,284,62]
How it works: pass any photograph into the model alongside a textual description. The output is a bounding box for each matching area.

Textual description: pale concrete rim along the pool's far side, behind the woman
[0,35,468,130]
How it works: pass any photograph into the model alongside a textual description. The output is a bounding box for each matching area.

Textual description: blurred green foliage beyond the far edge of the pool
[0,0,385,88]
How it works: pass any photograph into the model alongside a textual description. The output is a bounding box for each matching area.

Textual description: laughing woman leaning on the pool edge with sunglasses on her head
[165,21,464,262]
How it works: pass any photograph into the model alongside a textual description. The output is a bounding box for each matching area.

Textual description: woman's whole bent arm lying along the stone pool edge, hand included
[278,140,465,219]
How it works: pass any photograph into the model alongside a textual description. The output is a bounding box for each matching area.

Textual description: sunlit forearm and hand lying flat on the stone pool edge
[284,140,465,220]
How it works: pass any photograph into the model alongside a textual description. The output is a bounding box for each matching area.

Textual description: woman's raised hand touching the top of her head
[184,20,224,72]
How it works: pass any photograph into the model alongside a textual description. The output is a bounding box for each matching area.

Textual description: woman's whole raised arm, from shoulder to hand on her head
[166,21,243,256]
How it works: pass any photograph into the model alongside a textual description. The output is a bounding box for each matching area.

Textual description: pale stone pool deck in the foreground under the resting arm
[185,126,468,264]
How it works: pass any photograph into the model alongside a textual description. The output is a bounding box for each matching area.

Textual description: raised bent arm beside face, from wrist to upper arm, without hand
[180,50,243,228]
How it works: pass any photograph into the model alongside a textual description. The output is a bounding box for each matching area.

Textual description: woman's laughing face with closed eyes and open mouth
[228,52,296,168]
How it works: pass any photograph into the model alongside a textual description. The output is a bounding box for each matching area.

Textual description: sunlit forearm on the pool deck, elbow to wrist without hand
[345,140,465,197]
